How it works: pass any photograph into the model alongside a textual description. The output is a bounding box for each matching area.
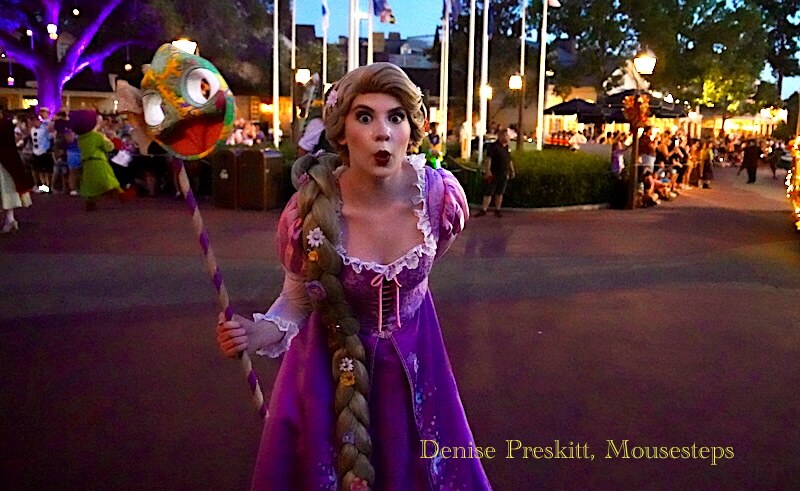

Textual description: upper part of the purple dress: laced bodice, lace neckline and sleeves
[266,155,469,350]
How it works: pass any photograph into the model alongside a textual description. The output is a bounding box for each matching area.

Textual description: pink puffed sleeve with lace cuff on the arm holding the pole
[253,194,312,358]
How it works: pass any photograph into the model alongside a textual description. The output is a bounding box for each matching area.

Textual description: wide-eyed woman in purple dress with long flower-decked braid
[217,63,490,491]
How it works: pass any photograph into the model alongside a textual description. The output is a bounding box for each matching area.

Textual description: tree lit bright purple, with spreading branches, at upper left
[0,0,161,111]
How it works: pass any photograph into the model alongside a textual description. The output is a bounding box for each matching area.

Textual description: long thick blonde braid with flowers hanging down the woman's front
[292,153,375,491]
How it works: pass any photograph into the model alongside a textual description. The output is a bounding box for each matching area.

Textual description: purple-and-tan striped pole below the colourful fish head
[172,157,269,420]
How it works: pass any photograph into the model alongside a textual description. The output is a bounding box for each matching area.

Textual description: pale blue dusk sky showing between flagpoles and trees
[297,0,800,99]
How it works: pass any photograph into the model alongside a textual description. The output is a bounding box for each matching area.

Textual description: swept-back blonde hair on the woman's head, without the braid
[323,63,428,163]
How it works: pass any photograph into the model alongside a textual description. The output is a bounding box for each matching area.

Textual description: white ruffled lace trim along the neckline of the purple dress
[335,154,436,280]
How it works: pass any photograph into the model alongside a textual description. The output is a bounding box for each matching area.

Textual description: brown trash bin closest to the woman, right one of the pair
[237,150,285,210]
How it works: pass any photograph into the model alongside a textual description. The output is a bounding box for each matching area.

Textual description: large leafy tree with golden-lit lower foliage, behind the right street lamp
[620,0,767,119]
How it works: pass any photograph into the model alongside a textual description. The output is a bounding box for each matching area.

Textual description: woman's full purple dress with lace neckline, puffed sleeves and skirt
[252,155,491,491]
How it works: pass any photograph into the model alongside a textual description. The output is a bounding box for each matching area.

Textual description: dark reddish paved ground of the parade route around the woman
[0,169,800,490]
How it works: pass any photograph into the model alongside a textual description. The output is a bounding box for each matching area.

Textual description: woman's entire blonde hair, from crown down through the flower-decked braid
[292,63,426,491]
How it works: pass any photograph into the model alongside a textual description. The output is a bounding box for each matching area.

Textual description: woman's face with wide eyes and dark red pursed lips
[339,93,411,177]
